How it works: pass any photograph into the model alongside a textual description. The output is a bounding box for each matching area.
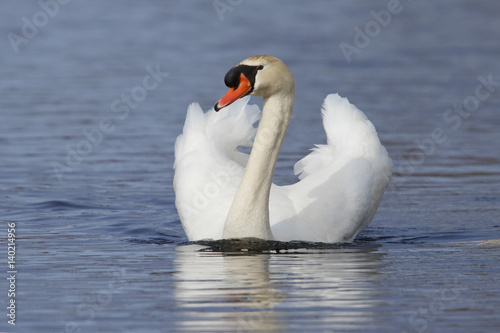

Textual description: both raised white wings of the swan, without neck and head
[174,55,392,242]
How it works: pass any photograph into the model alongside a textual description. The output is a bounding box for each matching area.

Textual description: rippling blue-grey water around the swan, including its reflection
[0,0,500,333]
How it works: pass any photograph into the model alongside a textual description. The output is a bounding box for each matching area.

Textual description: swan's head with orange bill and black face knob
[214,55,295,111]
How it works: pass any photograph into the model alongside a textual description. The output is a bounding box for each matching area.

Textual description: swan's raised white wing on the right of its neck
[270,94,392,242]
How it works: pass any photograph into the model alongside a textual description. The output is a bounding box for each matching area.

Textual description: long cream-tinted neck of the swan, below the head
[222,92,295,240]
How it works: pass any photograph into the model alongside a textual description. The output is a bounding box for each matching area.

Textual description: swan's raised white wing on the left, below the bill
[174,97,260,240]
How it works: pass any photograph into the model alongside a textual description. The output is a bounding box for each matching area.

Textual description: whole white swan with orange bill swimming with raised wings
[174,55,392,242]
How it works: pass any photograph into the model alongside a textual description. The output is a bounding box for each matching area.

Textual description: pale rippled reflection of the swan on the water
[174,244,384,332]
